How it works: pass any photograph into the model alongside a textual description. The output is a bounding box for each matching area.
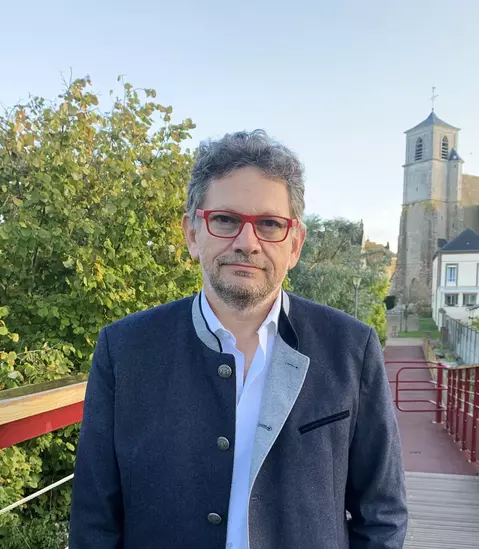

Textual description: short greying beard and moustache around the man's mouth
[205,253,281,311]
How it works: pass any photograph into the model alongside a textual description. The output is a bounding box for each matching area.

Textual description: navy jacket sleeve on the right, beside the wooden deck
[346,330,408,549]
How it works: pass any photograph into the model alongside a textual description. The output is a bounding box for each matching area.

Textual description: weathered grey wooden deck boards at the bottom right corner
[404,472,479,549]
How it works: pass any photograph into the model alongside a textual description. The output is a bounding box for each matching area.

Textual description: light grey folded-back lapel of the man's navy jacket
[249,334,309,495]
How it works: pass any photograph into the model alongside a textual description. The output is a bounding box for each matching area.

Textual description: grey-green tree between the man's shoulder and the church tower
[289,216,389,344]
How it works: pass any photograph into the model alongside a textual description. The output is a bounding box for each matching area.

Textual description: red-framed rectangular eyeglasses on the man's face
[196,210,298,242]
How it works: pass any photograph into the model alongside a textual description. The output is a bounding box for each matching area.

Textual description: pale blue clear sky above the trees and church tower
[0,0,479,250]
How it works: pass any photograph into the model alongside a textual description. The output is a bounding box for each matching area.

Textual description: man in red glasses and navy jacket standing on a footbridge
[69,131,407,549]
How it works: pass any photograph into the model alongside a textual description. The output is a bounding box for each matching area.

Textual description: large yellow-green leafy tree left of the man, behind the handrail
[0,74,200,535]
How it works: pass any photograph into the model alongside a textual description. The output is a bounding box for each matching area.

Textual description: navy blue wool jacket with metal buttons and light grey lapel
[69,293,407,549]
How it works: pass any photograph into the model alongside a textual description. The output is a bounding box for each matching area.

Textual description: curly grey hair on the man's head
[186,130,304,221]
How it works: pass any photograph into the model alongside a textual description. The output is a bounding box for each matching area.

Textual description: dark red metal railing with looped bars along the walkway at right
[386,360,479,463]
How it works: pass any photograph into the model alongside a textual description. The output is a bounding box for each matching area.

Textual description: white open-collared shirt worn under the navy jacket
[201,292,281,549]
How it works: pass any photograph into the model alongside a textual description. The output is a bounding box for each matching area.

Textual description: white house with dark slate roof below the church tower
[432,229,479,326]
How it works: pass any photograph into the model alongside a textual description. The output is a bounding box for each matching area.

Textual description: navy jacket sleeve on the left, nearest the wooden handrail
[68,329,123,549]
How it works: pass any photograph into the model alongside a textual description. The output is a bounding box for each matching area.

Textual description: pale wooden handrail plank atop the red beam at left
[0,375,87,425]
